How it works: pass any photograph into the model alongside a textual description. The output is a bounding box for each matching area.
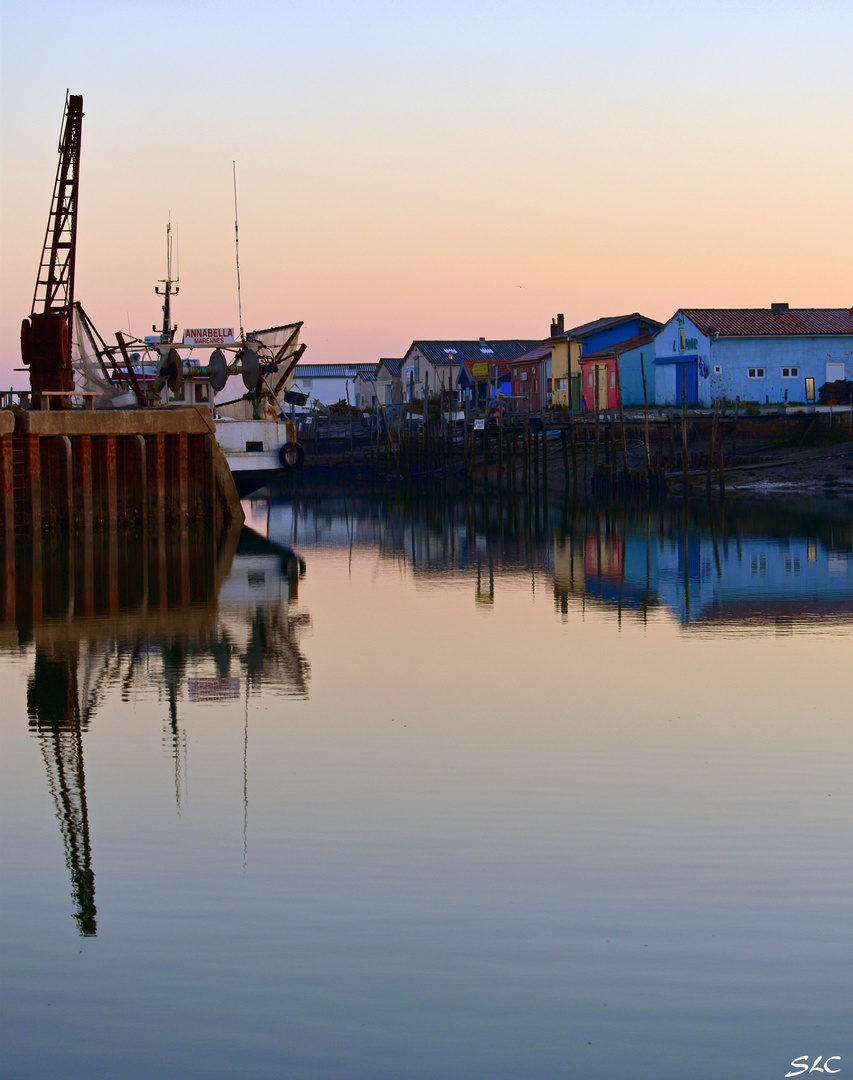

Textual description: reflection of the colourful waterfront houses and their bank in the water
[267,498,853,632]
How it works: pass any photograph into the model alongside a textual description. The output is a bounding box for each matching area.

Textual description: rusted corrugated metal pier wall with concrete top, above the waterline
[0,407,243,539]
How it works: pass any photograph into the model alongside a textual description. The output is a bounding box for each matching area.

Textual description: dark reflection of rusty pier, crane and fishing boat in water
[0,518,309,936]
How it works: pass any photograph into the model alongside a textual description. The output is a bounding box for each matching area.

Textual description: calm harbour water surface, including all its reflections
[0,499,853,1080]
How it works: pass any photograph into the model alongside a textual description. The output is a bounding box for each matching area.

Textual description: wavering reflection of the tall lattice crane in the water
[27,648,97,937]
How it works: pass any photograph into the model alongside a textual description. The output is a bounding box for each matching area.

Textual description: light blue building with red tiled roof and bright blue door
[654,303,853,405]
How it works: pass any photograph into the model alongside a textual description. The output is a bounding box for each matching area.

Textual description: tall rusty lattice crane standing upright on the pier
[21,94,83,408]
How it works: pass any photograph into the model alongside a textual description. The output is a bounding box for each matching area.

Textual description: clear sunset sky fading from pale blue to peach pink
[0,0,853,389]
